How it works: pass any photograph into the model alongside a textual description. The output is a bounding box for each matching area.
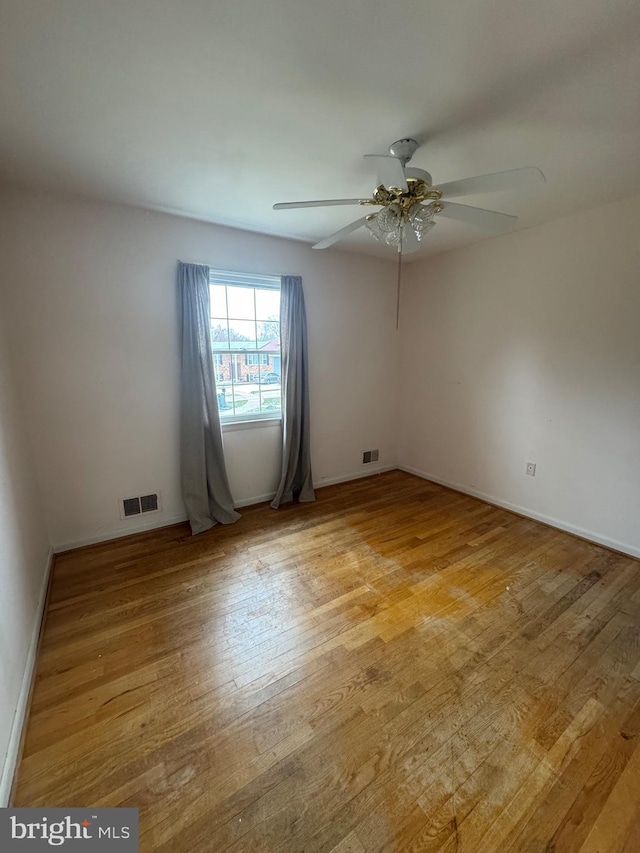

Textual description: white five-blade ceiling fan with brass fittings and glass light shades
[273,139,545,255]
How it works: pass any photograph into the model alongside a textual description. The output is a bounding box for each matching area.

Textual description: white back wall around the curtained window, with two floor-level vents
[0,191,398,549]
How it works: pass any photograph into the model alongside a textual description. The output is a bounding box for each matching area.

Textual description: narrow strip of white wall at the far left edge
[0,307,50,807]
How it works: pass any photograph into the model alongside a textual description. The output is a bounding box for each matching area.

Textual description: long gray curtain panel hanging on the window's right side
[271,275,316,509]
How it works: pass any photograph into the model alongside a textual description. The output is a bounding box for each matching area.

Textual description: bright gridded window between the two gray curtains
[209,270,282,423]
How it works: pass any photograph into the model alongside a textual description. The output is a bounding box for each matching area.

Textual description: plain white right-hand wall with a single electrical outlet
[399,190,640,556]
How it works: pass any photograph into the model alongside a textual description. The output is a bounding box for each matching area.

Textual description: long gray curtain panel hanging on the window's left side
[178,263,240,534]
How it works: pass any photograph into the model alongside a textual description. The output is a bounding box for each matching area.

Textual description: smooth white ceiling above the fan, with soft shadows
[0,0,640,254]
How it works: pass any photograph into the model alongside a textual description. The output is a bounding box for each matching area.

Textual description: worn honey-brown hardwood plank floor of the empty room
[15,471,640,853]
